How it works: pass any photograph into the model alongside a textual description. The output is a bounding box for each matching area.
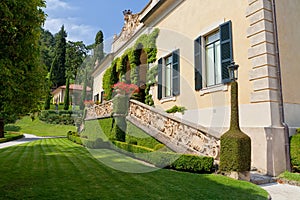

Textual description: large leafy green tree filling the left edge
[0,0,45,137]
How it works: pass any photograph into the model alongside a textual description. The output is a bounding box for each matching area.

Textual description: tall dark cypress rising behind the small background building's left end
[51,26,67,88]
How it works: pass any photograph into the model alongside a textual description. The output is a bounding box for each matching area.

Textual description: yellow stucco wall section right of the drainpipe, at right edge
[276,0,300,104]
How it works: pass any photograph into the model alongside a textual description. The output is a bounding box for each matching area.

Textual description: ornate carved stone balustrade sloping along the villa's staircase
[86,100,220,161]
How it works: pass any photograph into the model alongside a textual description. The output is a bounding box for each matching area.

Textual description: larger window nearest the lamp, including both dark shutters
[194,21,233,90]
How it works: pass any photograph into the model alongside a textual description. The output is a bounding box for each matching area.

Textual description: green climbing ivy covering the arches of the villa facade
[102,29,159,105]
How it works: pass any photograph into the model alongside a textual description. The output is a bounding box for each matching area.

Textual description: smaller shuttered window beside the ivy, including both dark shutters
[158,50,180,99]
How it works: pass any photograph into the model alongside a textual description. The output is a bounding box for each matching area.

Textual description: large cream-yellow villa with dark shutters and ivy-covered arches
[91,0,300,175]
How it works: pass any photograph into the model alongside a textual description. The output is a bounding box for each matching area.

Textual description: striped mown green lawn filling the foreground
[0,138,267,200]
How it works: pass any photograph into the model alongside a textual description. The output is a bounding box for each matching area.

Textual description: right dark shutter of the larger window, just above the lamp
[220,21,233,83]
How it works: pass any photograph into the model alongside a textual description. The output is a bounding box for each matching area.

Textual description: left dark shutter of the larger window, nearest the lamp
[194,36,203,91]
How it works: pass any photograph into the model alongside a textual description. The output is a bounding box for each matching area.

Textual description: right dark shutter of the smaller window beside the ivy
[172,49,180,96]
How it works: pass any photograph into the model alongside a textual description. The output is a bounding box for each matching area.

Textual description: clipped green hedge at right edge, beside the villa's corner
[290,129,300,172]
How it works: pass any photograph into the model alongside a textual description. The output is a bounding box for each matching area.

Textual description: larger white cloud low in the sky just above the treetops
[44,18,97,45]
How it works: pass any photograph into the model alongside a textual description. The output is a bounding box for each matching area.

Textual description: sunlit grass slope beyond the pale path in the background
[5,116,76,136]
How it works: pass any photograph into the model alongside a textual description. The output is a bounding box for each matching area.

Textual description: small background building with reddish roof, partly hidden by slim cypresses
[52,84,92,105]
